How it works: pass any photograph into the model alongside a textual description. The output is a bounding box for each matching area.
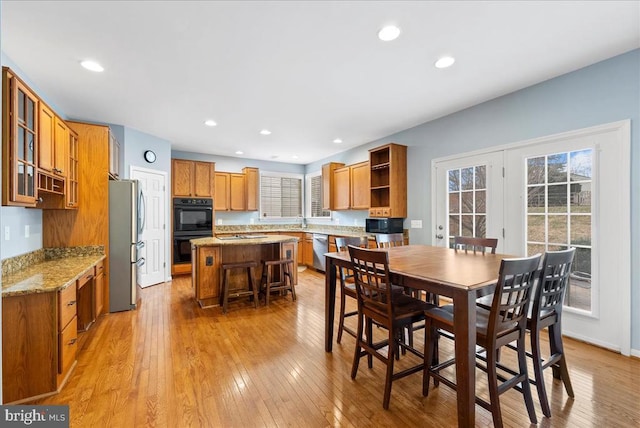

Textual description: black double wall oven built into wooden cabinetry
[173,198,213,264]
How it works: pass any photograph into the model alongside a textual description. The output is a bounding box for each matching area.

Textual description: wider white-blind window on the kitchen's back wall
[260,173,302,219]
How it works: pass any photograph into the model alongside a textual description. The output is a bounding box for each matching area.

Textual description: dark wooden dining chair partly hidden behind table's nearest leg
[422,254,542,427]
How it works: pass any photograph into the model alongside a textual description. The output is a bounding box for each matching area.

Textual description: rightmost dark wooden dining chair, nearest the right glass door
[527,248,576,417]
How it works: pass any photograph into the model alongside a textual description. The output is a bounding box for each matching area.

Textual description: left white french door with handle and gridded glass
[432,151,503,252]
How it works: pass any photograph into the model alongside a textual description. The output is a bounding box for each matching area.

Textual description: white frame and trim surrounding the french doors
[431,119,633,356]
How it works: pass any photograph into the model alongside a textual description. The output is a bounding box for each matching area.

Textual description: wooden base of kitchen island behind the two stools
[191,242,298,307]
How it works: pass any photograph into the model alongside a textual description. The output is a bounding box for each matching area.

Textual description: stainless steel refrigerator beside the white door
[109,180,145,312]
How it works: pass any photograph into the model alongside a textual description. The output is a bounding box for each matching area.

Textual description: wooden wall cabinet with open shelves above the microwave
[369,143,407,218]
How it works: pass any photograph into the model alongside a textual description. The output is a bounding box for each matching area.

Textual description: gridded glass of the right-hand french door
[526,149,593,311]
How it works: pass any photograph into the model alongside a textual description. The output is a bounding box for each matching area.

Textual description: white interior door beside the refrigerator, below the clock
[131,168,167,287]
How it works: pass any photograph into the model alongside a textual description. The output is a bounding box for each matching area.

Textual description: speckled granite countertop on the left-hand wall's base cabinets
[2,255,105,297]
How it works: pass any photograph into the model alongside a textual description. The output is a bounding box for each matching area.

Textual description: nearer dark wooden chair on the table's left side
[348,245,435,409]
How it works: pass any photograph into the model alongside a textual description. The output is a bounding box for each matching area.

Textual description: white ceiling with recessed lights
[1,0,640,164]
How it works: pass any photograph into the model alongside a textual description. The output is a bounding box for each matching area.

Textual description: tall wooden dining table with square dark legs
[325,245,512,427]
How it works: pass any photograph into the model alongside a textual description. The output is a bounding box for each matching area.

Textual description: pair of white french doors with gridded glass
[433,121,631,355]
